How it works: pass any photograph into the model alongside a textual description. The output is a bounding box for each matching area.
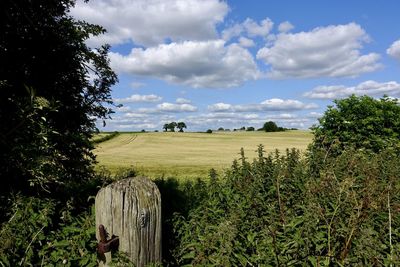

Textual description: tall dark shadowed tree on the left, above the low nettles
[0,0,117,194]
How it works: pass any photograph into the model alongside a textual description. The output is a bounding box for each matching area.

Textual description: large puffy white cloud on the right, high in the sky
[257,23,381,78]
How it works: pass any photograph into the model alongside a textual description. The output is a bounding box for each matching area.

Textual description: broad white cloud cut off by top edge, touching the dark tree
[71,0,229,46]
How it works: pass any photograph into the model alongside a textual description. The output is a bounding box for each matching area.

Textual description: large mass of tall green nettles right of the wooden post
[174,146,400,266]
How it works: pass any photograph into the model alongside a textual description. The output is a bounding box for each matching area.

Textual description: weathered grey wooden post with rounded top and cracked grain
[95,177,161,267]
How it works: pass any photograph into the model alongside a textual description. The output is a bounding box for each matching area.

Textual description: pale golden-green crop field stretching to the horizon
[95,131,312,179]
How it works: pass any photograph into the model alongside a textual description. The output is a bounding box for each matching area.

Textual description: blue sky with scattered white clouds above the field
[71,0,400,131]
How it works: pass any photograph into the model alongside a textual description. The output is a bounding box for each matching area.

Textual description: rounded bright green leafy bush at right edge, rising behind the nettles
[313,95,400,152]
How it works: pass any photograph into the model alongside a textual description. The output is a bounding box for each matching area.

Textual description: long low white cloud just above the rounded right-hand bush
[304,81,400,99]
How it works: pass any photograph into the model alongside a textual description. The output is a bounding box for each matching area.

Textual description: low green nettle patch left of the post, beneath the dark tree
[0,195,97,266]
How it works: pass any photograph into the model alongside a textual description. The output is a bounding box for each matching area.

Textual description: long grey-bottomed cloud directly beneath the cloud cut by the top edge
[110,40,260,88]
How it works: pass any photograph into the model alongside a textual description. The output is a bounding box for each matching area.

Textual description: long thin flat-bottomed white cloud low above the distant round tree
[208,98,318,112]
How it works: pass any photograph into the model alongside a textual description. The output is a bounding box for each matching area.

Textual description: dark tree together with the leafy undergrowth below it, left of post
[0,0,117,266]
